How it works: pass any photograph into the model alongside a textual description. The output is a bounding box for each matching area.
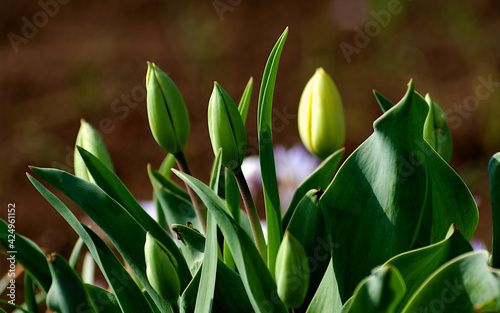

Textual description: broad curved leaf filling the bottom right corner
[402,251,500,313]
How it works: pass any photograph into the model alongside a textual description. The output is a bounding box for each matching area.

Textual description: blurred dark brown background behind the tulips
[0,0,500,264]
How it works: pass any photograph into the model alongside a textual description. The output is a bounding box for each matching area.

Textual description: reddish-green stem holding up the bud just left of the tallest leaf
[233,166,267,263]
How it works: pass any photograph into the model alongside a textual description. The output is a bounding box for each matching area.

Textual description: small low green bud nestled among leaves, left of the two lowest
[144,232,181,305]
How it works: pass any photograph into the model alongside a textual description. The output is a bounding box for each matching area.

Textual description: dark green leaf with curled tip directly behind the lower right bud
[286,189,331,308]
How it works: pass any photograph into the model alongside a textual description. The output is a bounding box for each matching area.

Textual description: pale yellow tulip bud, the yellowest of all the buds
[297,68,345,160]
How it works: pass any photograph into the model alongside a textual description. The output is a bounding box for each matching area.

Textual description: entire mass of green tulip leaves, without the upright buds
[0,30,500,313]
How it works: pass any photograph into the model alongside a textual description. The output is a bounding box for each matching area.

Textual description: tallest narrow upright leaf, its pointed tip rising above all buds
[257,27,288,277]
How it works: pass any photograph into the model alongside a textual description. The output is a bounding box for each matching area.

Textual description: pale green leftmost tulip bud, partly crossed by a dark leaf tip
[73,119,114,182]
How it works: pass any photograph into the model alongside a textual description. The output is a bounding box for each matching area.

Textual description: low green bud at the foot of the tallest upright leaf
[276,231,310,308]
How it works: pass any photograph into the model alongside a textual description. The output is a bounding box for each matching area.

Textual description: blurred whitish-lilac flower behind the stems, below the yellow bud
[241,144,319,212]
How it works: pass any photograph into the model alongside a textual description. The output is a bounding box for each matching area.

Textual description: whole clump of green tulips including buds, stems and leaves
[0,29,500,313]
